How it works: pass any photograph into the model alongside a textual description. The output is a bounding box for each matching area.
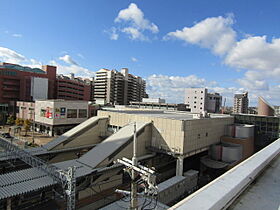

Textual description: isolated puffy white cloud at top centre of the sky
[110,3,159,41]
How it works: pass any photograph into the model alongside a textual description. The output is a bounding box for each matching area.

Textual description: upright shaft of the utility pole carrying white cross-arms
[131,122,138,209]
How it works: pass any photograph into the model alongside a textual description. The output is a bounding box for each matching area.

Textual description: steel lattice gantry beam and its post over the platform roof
[0,138,76,210]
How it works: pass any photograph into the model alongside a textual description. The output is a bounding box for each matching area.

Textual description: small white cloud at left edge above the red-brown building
[0,47,27,63]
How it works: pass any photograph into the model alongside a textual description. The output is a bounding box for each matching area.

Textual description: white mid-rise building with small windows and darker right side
[185,88,222,113]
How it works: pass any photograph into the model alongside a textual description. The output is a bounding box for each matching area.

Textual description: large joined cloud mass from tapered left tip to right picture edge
[164,15,280,101]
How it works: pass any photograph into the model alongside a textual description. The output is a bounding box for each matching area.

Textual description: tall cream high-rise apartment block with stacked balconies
[94,68,146,105]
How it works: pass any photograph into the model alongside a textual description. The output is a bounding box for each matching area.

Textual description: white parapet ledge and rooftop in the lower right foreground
[170,139,280,210]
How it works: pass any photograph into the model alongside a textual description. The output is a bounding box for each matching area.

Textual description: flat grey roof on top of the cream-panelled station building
[103,108,230,120]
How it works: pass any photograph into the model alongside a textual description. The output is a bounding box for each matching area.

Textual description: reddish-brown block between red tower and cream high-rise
[56,73,93,101]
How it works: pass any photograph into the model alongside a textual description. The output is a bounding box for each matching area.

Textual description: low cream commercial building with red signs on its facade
[35,99,88,136]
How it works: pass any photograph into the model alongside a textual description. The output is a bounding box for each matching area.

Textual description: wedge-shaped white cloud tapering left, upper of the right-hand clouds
[164,15,236,55]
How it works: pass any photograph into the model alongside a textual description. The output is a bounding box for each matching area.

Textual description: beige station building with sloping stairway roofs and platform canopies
[0,110,234,209]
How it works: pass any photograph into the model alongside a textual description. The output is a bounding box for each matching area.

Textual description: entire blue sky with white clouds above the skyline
[0,0,280,106]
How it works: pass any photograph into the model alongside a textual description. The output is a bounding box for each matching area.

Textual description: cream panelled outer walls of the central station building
[98,111,234,154]
